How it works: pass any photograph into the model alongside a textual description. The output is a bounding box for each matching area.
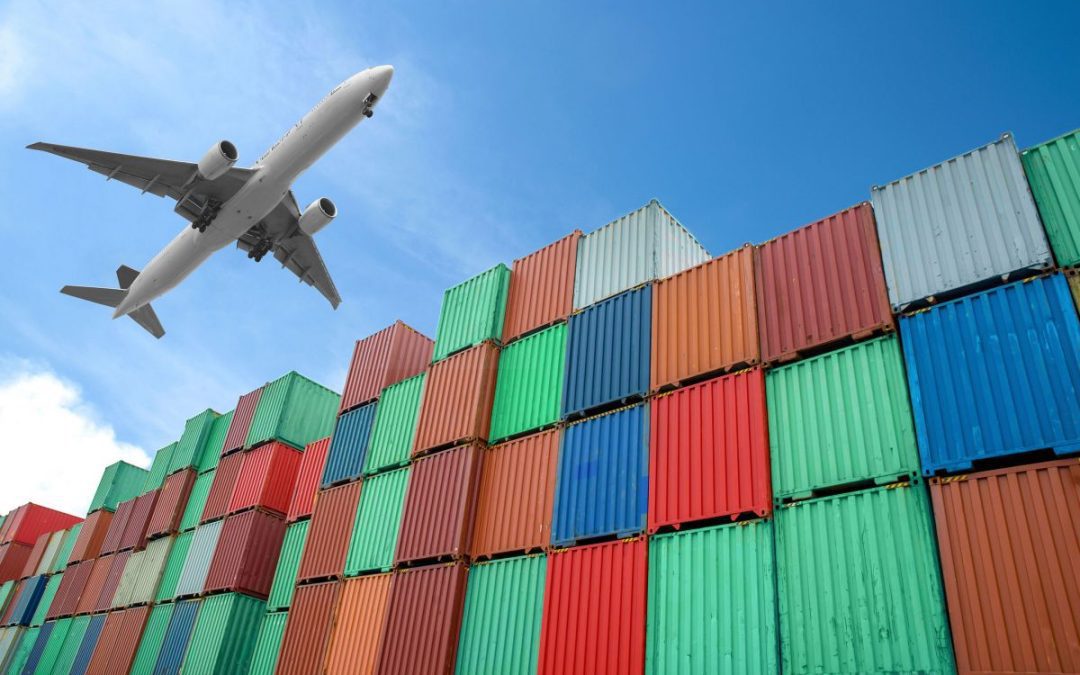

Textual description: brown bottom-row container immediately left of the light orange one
[275,581,341,675]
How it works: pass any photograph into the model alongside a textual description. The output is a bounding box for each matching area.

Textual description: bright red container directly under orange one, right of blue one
[649,368,772,532]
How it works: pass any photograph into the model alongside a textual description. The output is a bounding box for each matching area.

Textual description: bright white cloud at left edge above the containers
[0,360,150,515]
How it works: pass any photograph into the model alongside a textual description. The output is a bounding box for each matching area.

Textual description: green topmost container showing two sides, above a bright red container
[244,372,341,449]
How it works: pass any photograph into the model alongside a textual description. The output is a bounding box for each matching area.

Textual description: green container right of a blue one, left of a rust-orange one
[364,373,427,475]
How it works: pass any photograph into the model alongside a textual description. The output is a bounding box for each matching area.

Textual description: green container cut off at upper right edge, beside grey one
[1020,130,1080,266]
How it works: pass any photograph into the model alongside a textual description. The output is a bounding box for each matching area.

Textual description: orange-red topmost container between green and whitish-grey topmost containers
[502,230,581,342]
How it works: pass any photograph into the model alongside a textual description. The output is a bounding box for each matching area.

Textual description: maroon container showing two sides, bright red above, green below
[203,510,286,599]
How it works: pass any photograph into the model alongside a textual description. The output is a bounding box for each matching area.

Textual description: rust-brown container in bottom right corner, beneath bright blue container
[930,459,1080,673]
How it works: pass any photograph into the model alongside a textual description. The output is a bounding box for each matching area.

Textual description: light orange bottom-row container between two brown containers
[326,575,391,675]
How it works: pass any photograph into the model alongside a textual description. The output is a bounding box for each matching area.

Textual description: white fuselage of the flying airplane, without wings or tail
[112,66,393,319]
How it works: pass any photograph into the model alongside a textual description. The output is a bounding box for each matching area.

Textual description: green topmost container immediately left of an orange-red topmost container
[432,262,510,362]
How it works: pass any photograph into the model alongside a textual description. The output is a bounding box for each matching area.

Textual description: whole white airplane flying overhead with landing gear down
[27,66,394,338]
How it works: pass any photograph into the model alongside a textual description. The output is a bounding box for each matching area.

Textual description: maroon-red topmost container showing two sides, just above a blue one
[340,321,435,413]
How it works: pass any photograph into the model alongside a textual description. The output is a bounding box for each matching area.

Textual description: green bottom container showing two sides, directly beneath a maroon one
[184,593,267,675]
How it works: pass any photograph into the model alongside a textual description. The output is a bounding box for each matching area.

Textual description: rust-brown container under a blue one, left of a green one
[297,481,361,581]
